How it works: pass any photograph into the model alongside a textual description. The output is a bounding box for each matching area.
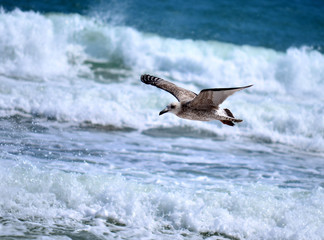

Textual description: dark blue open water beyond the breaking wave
[0,0,324,52]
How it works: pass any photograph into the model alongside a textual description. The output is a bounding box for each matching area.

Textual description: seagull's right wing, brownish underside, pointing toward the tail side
[189,85,253,109]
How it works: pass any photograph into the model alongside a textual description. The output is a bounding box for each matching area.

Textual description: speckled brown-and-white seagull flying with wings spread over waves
[141,74,253,126]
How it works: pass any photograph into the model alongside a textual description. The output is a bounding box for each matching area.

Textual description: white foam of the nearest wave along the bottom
[0,161,324,239]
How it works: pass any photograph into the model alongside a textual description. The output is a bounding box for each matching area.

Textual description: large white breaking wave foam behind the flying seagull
[0,10,324,152]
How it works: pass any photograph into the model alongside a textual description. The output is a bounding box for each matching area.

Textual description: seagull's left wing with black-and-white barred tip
[141,74,197,102]
